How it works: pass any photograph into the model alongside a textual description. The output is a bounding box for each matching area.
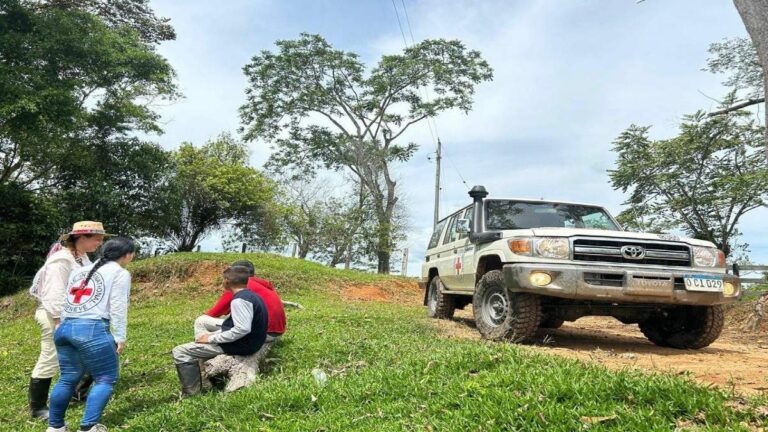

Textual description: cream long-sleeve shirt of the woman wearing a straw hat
[38,249,91,318]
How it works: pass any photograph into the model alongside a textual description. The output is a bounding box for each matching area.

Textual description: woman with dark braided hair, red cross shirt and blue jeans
[47,238,136,432]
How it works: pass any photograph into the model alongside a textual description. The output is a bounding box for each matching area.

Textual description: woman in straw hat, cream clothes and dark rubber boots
[29,221,106,419]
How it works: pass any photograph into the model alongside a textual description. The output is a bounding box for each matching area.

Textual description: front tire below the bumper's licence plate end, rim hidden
[640,305,725,349]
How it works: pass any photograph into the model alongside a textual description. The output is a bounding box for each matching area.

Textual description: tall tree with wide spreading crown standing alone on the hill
[241,34,492,273]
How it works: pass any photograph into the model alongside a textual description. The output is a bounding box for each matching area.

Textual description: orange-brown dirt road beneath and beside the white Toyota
[341,283,768,394]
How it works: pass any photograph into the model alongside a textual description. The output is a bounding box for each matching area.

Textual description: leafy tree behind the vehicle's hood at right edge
[609,111,768,254]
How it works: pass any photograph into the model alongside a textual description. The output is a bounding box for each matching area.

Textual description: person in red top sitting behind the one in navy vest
[195,260,286,342]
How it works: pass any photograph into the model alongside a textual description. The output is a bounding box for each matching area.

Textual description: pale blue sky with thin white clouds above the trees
[152,0,768,275]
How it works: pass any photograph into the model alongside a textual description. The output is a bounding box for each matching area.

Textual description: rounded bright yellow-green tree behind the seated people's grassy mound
[156,134,275,251]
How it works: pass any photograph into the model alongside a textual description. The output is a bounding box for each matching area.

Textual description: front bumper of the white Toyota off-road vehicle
[504,263,741,305]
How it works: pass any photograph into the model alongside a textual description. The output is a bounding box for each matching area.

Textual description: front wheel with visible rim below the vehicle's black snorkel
[472,270,541,342]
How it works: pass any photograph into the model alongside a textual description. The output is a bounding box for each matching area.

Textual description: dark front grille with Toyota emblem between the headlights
[573,239,691,267]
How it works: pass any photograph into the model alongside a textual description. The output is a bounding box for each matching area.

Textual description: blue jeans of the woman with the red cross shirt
[48,318,118,428]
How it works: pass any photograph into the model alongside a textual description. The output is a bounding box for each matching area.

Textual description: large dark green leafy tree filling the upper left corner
[0,0,177,190]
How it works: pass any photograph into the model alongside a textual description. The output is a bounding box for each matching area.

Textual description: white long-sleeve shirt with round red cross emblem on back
[61,261,131,343]
